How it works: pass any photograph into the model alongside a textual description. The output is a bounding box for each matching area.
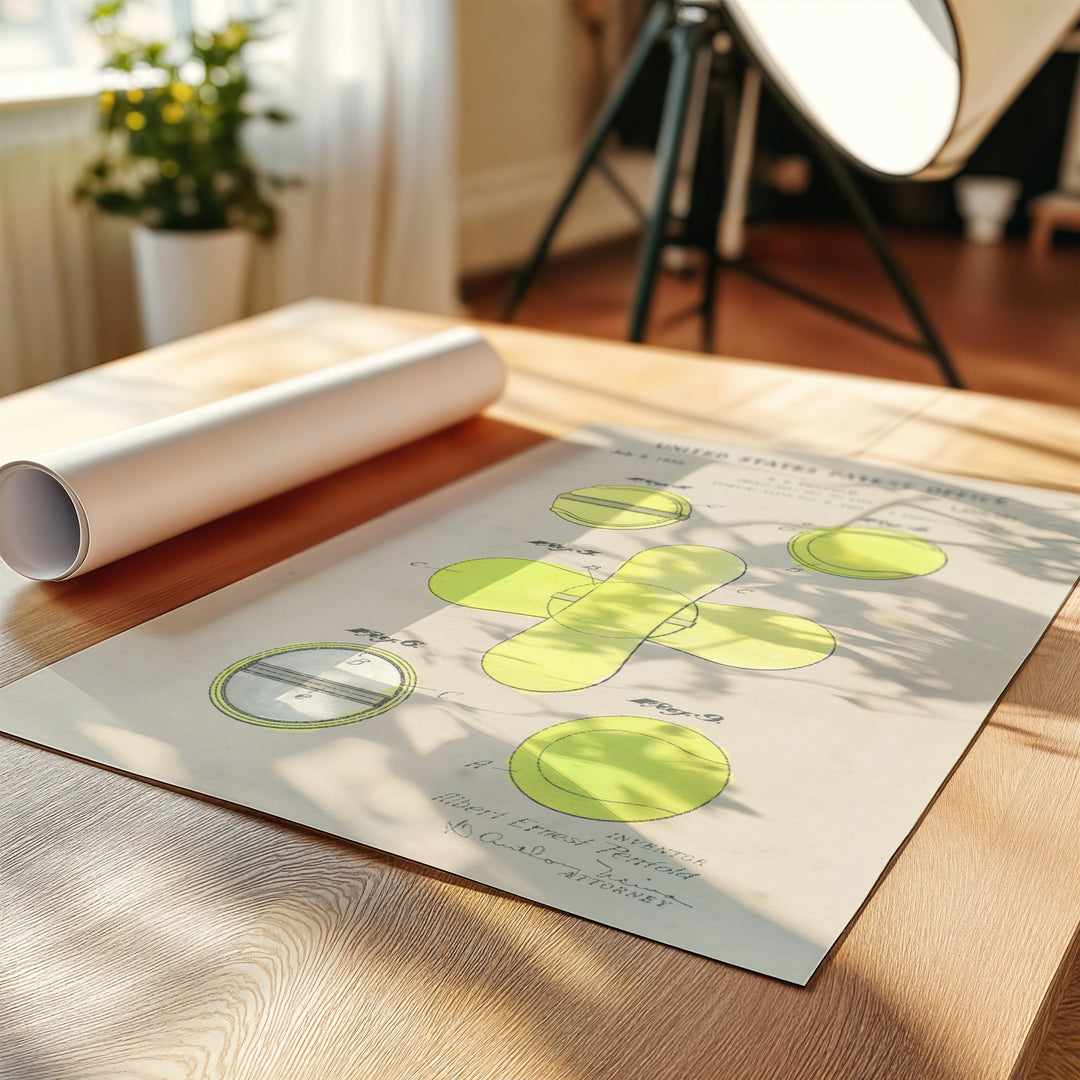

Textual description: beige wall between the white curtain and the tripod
[457,0,651,274]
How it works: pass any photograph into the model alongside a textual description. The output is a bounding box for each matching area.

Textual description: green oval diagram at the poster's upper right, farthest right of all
[787,526,946,581]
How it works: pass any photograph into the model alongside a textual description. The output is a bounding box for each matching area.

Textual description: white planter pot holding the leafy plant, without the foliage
[132,225,254,346]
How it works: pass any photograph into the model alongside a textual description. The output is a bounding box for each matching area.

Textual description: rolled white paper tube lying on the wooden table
[0,327,505,581]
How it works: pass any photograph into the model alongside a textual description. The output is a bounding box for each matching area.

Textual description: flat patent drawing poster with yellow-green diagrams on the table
[6,429,1080,984]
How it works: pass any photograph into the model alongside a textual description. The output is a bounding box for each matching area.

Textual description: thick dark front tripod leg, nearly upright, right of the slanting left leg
[626,23,711,341]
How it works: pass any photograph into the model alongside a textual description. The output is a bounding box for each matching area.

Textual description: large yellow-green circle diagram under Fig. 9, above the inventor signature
[510,716,731,822]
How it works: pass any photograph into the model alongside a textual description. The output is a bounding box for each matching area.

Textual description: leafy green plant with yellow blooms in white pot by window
[76,0,288,345]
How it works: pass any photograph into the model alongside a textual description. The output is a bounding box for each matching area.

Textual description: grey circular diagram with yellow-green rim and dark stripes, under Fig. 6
[210,642,416,730]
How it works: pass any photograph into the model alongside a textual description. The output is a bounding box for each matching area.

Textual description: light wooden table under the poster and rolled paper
[0,300,1080,1080]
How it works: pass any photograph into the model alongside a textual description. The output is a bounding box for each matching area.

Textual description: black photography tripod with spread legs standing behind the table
[503,0,962,387]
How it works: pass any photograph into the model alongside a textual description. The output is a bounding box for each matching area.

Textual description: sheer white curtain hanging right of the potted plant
[255,0,458,313]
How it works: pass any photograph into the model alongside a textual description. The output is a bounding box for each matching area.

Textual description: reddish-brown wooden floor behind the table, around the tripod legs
[465,222,1080,406]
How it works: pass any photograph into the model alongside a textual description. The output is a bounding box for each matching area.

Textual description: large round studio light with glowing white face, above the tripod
[725,0,1078,179]
